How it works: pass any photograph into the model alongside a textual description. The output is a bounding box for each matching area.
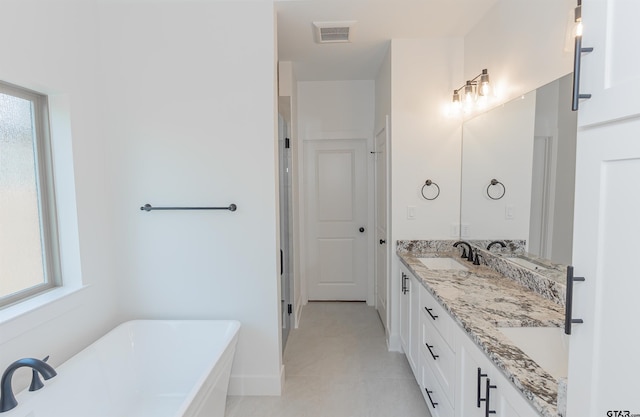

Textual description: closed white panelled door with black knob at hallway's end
[305,139,369,301]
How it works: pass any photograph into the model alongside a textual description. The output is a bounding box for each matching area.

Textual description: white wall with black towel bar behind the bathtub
[100,1,281,395]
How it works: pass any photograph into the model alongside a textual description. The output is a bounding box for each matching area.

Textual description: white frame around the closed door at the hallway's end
[294,130,376,306]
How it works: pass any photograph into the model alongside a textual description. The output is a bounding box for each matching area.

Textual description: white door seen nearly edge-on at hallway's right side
[375,120,390,330]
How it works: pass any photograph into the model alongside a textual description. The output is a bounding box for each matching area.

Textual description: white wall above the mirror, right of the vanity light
[464,0,576,109]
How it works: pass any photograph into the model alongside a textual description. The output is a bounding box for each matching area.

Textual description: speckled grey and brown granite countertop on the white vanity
[398,251,564,417]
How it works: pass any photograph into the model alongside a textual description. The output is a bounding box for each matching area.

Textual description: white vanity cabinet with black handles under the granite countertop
[400,266,539,417]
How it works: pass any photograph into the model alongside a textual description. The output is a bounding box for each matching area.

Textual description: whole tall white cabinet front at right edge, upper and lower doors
[567,0,640,417]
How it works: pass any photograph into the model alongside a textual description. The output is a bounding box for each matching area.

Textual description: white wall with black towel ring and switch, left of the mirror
[389,38,463,350]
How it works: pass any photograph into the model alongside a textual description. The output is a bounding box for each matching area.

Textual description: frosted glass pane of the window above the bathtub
[0,93,45,297]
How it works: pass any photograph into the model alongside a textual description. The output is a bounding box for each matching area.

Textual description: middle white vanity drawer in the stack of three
[420,316,456,404]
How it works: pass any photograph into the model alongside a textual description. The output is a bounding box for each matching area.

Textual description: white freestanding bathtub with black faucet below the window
[0,320,240,417]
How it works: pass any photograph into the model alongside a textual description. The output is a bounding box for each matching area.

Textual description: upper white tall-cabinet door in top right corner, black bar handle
[578,0,640,126]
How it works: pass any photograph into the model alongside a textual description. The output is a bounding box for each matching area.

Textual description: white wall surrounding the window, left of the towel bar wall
[0,0,116,390]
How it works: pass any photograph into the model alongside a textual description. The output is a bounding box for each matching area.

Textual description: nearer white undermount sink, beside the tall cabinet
[498,327,569,379]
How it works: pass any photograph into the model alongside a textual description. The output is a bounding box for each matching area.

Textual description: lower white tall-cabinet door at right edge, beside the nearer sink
[567,119,640,417]
